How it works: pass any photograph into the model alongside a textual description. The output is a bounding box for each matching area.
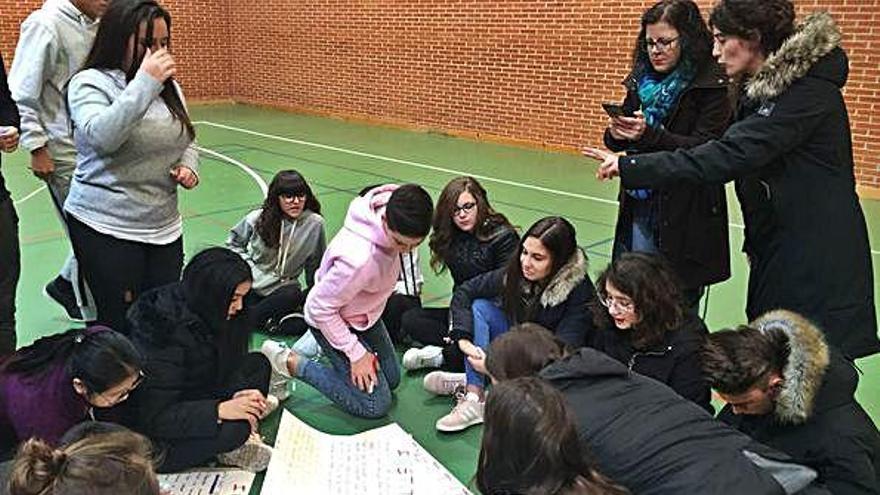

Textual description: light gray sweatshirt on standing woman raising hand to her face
[64,69,198,244]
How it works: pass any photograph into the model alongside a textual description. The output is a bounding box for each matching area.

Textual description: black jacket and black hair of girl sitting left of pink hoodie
[127,252,249,440]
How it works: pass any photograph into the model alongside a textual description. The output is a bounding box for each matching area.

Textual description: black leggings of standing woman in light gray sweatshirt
[67,215,183,333]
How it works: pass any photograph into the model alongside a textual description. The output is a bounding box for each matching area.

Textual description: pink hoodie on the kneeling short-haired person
[304,184,400,362]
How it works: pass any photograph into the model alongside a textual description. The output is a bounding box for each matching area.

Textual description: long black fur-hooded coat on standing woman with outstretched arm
[619,12,880,358]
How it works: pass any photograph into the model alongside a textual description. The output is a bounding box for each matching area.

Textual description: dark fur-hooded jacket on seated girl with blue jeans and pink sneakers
[449,249,596,347]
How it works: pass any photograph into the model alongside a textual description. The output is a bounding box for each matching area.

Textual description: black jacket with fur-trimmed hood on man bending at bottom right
[718,310,880,495]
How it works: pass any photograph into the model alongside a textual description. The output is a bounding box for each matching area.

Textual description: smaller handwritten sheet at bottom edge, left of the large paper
[159,469,255,495]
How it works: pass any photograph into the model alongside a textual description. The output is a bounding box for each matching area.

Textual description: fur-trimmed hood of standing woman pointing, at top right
[746,11,849,101]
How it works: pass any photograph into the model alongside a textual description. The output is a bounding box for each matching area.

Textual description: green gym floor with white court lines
[3,105,880,493]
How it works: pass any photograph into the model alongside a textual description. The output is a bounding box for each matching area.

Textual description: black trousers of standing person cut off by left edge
[0,198,21,356]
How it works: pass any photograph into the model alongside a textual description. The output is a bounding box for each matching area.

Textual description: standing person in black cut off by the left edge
[0,56,21,356]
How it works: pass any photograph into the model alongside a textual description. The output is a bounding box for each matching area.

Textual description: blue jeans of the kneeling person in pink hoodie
[297,319,400,418]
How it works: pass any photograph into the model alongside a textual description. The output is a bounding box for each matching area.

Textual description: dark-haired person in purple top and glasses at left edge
[0,327,144,456]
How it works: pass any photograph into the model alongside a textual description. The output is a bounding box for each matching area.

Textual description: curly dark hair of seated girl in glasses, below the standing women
[591,253,684,349]
